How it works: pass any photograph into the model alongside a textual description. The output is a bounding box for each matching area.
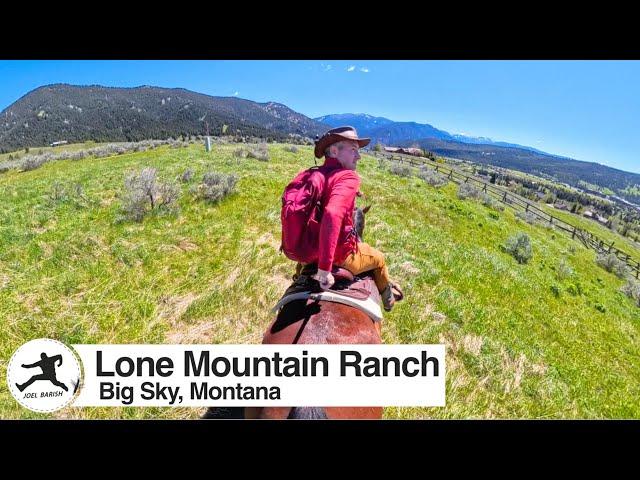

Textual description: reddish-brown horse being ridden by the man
[203,207,382,419]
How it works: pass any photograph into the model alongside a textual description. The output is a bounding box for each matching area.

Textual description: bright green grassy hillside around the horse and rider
[0,145,640,418]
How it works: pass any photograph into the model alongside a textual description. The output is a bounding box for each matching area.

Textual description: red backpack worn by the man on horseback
[280,167,326,263]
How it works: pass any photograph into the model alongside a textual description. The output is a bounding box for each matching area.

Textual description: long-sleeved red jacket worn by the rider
[318,157,360,271]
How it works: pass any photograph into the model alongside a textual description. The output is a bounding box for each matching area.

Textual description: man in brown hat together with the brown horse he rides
[203,127,402,419]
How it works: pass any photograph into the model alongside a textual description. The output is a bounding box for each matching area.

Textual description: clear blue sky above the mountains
[0,60,640,173]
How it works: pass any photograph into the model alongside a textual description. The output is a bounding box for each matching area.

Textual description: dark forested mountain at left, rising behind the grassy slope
[0,84,328,152]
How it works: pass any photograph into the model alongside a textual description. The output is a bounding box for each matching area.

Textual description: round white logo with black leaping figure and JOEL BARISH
[7,338,80,412]
